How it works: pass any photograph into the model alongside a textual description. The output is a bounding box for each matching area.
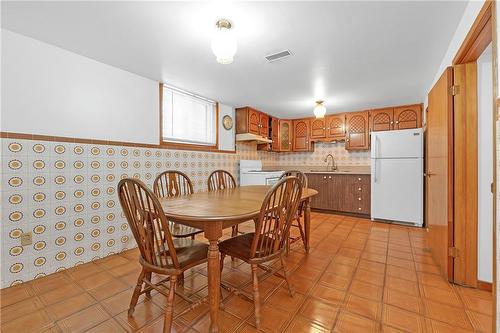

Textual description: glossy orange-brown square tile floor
[0,213,492,333]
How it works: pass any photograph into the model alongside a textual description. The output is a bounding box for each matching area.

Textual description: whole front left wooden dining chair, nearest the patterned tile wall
[118,178,208,332]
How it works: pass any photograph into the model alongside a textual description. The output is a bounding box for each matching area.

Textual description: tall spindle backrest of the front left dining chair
[118,178,180,269]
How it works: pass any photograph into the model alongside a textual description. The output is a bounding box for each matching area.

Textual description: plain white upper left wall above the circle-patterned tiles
[1,29,235,150]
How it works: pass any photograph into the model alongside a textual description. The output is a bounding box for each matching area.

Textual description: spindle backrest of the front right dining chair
[251,177,302,259]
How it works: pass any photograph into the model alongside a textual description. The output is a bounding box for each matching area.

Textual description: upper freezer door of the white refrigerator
[371,128,424,158]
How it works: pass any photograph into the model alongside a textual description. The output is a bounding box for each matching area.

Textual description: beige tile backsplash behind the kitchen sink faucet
[278,142,370,166]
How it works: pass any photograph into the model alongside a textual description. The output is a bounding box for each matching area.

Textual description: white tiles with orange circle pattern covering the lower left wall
[0,139,278,288]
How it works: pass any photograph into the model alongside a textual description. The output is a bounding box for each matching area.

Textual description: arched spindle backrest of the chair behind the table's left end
[153,170,194,198]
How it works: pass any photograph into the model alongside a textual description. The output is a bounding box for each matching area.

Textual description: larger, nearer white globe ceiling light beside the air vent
[212,19,238,65]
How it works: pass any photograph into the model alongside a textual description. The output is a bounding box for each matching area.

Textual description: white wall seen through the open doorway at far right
[477,45,493,282]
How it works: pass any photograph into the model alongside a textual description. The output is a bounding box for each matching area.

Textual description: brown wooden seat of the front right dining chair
[219,232,278,262]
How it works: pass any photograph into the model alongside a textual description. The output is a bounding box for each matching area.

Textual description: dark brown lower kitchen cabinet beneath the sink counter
[307,173,370,215]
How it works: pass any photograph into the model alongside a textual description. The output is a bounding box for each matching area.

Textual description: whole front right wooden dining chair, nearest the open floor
[219,177,302,329]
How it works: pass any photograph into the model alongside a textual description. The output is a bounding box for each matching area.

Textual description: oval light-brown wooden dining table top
[159,185,318,222]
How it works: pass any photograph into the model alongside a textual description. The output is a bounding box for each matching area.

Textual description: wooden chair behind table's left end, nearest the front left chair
[153,170,203,239]
